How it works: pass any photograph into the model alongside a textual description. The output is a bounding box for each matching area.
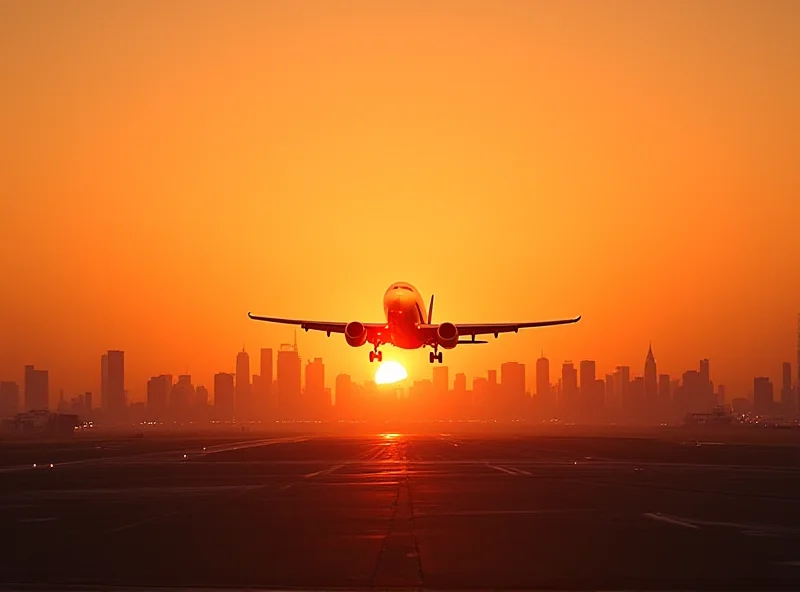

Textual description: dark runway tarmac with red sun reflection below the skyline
[0,430,800,590]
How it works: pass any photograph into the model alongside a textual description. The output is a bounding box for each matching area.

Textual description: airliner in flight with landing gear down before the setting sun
[247,282,581,364]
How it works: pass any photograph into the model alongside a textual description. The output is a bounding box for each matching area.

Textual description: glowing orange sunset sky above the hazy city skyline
[0,0,800,400]
